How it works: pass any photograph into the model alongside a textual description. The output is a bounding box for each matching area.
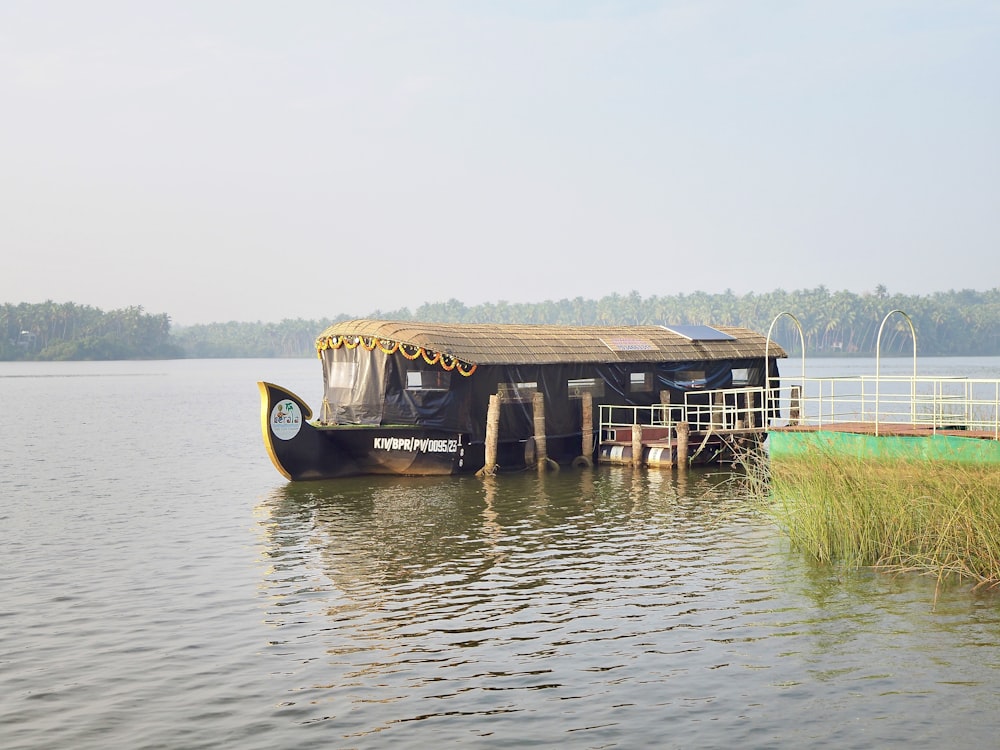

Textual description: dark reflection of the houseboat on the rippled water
[261,467,737,599]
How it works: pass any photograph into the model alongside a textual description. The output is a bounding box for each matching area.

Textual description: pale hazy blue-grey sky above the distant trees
[0,0,1000,324]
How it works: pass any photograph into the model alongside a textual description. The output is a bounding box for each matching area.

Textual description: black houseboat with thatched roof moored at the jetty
[258,319,786,481]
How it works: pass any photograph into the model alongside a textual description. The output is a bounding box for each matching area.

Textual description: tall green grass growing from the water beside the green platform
[743,451,1000,586]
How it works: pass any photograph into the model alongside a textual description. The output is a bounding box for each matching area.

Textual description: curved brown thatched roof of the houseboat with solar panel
[317,320,787,365]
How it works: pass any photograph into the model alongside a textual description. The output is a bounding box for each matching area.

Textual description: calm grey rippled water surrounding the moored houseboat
[0,359,1000,750]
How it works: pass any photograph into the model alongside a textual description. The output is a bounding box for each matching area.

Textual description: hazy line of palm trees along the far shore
[0,286,1000,360]
